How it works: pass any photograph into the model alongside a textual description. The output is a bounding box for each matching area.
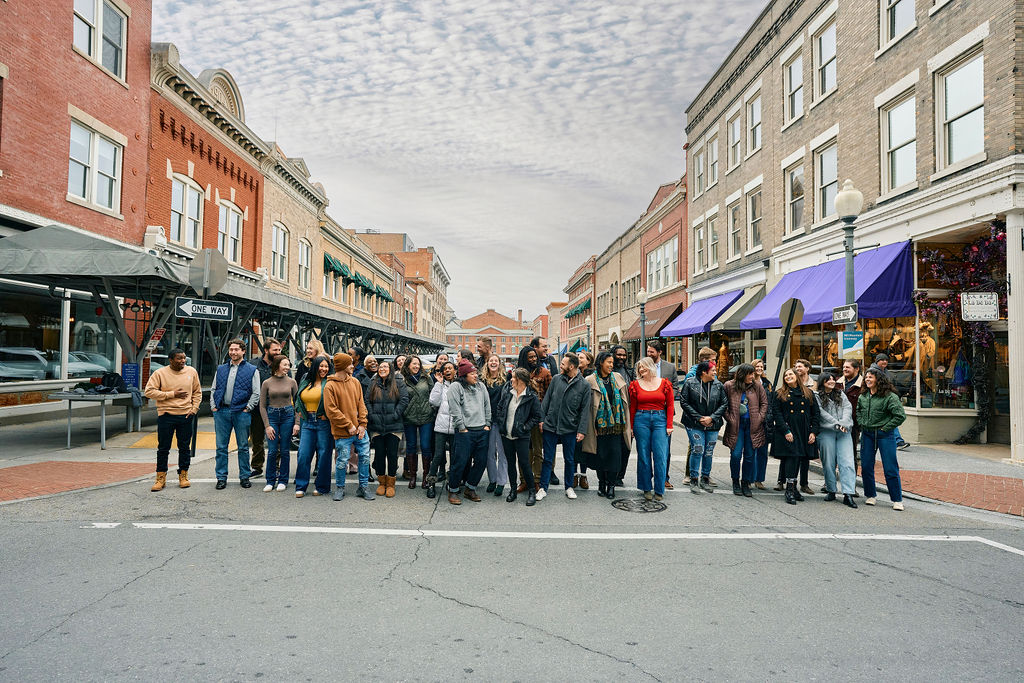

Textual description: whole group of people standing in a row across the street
[145,337,904,509]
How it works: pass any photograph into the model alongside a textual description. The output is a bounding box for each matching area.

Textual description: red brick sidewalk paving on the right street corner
[874,463,1024,516]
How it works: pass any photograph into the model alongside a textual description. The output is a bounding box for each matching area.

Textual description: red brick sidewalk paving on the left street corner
[0,461,156,501]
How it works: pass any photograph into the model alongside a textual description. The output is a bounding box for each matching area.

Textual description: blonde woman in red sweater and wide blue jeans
[630,357,675,501]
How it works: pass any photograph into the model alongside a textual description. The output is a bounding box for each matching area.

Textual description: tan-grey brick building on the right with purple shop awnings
[686,0,1024,446]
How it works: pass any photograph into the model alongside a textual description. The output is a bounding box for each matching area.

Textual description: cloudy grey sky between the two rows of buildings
[153,0,765,317]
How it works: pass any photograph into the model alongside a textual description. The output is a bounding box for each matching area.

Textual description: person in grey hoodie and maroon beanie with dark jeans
[447,358,490,505]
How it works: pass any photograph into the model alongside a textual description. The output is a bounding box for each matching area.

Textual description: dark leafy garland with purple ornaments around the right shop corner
[913,220,1007,443]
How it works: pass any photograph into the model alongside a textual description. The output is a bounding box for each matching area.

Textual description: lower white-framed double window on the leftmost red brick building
[68,121,122,211]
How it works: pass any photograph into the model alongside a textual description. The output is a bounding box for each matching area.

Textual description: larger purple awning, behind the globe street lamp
[739,242,916,330]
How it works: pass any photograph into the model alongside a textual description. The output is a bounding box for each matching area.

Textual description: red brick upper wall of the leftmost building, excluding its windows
[0,0,152,245]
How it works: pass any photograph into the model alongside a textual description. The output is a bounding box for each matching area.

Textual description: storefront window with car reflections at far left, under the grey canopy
[0,286,61,382]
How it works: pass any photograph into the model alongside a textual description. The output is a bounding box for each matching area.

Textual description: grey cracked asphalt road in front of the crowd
[0,462,1024,681]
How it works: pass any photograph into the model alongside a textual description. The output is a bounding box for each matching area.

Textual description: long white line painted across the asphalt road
[112,522,1024,557]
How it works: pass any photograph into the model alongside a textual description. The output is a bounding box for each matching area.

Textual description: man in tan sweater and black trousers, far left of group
[145,348,203,490]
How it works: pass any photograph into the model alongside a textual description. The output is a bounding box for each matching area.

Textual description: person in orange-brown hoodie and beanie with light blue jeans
[324,353,376,501]
